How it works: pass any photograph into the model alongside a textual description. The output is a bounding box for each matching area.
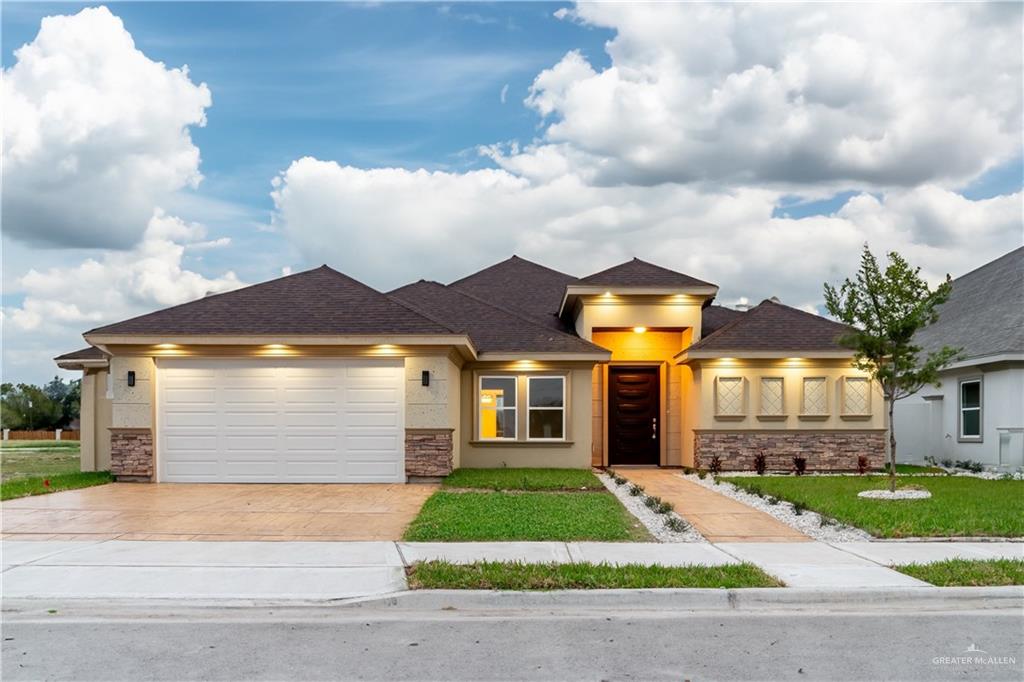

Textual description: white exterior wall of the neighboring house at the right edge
[893,364,1024,467]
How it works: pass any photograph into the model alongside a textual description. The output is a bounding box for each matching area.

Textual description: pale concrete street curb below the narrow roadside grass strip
[334,586,1024,611]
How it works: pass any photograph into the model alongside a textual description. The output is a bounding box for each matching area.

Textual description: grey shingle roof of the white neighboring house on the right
[914,247,1024,359]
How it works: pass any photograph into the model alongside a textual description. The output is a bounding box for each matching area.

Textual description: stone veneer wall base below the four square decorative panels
[693,430,885,471]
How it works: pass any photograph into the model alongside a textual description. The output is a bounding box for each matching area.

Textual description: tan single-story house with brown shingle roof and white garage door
[55,251,885,482]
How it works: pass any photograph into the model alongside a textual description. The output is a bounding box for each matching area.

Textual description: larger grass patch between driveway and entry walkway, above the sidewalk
[404,491,650,542]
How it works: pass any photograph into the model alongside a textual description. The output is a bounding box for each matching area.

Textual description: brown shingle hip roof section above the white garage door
[86,265,453,336]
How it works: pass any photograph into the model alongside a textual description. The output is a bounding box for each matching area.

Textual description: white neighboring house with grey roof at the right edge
[893,247,1024,468]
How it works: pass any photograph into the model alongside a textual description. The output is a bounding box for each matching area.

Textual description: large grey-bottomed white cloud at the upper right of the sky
[507,3,1022,188]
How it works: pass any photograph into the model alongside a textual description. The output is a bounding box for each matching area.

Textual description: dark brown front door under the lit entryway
[608,367,662,464]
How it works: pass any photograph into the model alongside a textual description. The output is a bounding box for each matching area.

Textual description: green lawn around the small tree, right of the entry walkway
[723,476,1024,538]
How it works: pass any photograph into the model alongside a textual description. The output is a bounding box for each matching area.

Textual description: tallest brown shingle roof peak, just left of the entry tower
[449,256,577,331]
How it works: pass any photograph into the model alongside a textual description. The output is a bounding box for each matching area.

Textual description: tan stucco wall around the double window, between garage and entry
[460,363,594,469]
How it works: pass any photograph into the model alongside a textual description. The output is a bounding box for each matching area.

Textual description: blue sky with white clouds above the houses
[0,2,1024,383]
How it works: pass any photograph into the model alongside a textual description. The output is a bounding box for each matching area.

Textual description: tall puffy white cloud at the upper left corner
[2,7,211,248]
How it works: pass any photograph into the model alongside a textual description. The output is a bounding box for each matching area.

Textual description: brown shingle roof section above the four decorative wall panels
[687,300,851,353]
